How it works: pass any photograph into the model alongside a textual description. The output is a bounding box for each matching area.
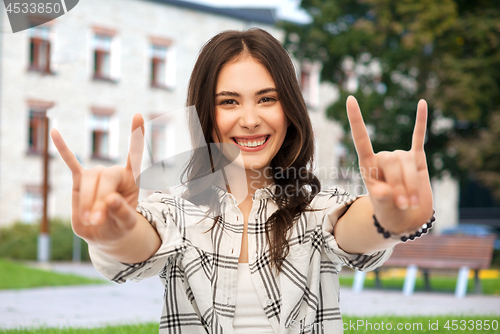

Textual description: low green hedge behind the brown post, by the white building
[0,218,89,261]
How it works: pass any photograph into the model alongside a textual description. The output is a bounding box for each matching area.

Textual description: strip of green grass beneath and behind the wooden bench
[339,273,500,295]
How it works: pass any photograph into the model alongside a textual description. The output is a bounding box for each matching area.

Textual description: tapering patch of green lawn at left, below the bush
[0,259,106,290]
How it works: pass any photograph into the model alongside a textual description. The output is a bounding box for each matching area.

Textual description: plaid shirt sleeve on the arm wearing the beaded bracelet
[321,187,393,271]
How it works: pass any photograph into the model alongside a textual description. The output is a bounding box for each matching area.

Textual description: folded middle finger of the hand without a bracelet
[89,166,123,225]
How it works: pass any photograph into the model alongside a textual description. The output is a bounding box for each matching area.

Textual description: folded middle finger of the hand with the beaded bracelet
[377,152,409,210]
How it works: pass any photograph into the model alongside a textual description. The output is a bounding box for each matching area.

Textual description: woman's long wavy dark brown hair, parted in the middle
[184,28,320,272]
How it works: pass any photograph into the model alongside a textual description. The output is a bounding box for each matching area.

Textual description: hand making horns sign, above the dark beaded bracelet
[347,96,433,233]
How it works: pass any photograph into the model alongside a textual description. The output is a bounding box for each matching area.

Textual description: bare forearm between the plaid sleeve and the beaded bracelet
[333,196,399,254]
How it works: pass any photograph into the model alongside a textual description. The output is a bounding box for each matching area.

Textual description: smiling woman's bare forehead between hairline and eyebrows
[216,56,276,94]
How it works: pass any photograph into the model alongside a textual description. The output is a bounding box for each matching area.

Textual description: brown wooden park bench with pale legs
[353,234,496,298]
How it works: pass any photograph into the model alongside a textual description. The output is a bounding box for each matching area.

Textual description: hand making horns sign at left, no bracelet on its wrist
[50,114,149,249]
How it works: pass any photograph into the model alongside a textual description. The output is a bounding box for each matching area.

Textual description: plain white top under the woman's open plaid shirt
[233,263,274,334]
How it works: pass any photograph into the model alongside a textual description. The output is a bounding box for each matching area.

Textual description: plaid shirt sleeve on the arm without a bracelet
[89,193,186,283]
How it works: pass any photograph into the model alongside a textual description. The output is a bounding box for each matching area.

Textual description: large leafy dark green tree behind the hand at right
[285,0,500,199]
